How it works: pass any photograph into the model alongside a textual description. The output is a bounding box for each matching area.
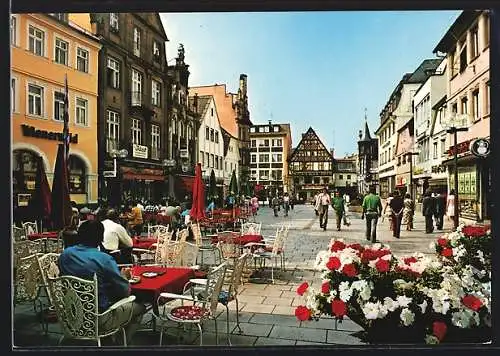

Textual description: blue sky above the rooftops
[161,10,460,157]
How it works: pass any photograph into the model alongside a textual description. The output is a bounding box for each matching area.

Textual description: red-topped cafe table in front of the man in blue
[130,266,195,315]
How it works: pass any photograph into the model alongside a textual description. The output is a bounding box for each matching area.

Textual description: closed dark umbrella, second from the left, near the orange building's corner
[51,143,72,230]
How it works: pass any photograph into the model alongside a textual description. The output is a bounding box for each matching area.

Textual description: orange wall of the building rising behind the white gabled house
[189,84,238,137]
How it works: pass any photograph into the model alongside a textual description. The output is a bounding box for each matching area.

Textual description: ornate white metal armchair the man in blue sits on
[48,274,135,347]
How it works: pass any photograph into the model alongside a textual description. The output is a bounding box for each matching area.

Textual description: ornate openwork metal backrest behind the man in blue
[48,275,99,340]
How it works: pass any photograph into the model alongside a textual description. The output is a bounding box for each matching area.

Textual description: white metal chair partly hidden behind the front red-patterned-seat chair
[190,253,252,345]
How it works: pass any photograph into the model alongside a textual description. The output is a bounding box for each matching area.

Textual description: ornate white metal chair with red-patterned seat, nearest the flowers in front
[157,263,226,346]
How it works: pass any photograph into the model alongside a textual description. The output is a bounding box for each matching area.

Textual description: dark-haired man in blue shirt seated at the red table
[59,220,145,340]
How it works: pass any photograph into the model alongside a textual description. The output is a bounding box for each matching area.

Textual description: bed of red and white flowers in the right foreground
[295,226,491,344]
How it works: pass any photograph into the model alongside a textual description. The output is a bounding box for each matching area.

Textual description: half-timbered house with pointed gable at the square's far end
[288,127,335,202]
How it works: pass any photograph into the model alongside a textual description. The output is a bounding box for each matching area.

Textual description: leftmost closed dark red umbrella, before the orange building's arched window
[30,156,52,230]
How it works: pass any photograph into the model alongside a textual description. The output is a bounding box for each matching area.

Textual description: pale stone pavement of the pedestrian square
[14,205,451,347]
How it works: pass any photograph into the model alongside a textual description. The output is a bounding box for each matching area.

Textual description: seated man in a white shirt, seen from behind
[102,209,134,264]
